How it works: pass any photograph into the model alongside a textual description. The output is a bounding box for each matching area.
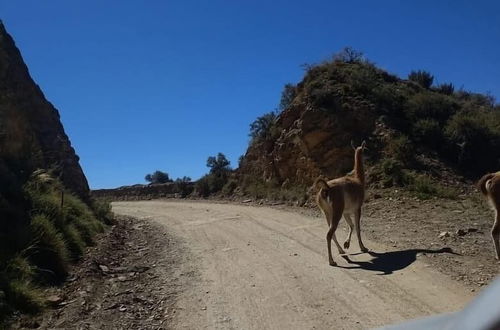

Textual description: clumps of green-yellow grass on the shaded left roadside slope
[0,171,113,315]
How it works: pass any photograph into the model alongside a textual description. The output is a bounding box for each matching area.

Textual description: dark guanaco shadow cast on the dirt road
[338,247,458,275]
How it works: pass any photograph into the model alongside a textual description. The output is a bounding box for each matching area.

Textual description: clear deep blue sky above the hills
[0,0,500,188]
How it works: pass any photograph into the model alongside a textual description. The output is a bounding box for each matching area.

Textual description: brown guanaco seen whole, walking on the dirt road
[315,141,368,266]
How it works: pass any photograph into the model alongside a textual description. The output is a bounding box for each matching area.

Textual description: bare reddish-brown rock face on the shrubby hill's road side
[238,101,375,185]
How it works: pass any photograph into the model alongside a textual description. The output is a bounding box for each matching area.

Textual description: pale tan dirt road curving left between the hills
[113,201,472,329]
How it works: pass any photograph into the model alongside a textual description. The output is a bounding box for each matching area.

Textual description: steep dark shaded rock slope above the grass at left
[0,21,89,198]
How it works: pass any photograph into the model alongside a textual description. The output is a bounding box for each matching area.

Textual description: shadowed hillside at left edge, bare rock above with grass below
[0,22,111,320]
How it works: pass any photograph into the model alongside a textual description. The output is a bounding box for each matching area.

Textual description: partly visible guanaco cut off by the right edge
[477,172,500,260]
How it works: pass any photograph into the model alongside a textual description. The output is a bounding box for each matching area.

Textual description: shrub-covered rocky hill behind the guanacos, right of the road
[238,49,500,192]
